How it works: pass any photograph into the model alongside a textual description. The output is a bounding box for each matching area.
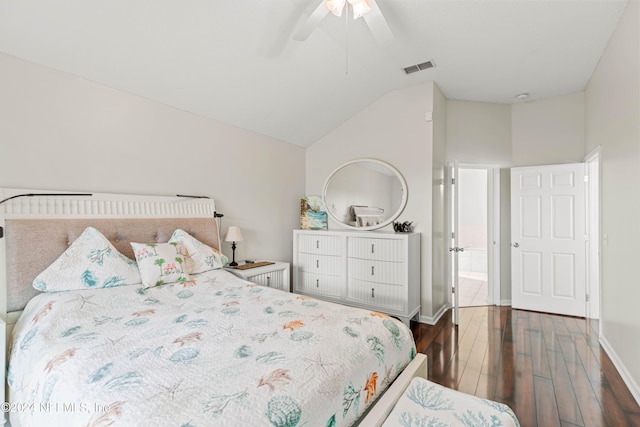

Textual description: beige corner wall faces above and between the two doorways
[447,92,585,304]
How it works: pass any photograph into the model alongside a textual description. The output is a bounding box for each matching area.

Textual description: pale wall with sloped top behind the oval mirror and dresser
[306,83,434,316]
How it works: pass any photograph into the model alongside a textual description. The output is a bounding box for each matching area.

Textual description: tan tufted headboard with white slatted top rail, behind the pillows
[0,189,220,322]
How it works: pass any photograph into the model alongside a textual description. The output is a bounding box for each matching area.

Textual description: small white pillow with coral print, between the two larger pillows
[131,241,191,288]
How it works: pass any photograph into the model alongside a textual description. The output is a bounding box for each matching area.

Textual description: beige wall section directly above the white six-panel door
[510,92,584,166]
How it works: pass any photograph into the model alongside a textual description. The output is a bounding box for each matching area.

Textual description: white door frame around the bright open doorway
[445,162,502,307]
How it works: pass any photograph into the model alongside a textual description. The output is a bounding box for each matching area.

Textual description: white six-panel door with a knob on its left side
[511,163,586,317]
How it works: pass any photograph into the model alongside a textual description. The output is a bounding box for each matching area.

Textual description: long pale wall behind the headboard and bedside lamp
[0,54,305,261]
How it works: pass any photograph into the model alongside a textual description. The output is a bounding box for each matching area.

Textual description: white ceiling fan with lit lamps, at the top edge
[293,0,394,46]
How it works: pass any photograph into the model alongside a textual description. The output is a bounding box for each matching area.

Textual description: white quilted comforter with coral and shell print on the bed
[8,270,415,427]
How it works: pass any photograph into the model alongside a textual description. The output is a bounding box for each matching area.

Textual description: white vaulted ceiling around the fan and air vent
[0,0,627,146]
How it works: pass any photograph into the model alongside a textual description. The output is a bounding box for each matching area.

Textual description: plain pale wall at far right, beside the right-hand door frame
[585,0,640,401]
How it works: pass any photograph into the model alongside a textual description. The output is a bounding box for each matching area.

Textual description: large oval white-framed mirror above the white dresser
[322,159,407,230]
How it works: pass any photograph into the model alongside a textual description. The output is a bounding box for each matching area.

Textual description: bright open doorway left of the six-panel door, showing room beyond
[458,166,492,307]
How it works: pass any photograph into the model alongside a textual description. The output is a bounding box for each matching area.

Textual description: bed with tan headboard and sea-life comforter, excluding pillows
[0,189,424,426]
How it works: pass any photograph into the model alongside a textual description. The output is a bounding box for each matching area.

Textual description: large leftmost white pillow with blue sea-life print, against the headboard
[33,227,141,292]
